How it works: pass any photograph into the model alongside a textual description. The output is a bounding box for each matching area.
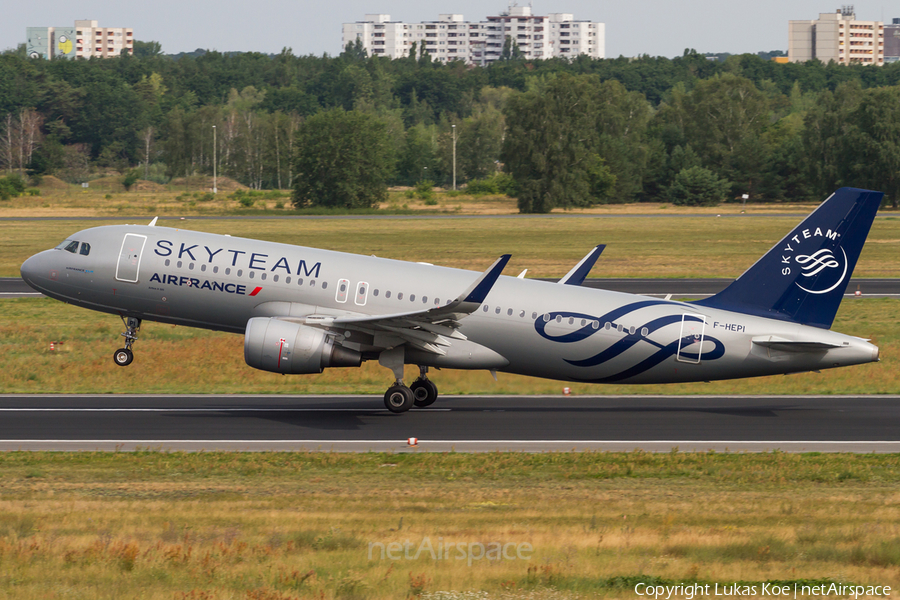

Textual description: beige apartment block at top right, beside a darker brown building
[788,6,885,65]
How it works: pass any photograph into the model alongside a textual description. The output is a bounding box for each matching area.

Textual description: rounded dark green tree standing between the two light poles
[293,108,394,208]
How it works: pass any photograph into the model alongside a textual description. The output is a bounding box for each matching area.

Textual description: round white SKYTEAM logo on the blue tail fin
[781,227,847,294]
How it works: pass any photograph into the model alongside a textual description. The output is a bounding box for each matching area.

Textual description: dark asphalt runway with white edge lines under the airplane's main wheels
[0,394,900,452]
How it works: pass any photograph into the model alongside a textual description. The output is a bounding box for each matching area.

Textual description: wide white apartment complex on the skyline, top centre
[342,6,606,65]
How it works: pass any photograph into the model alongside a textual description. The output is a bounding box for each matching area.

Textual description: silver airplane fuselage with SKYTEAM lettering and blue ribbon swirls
[23,225,878,383]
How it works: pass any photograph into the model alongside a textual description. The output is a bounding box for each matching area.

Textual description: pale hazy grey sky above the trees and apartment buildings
[0,0,900,57]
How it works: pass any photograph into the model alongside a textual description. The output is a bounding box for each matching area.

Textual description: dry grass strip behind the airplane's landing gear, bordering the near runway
[0,299,900,395]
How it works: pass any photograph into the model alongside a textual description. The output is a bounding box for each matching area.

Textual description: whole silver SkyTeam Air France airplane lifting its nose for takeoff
[22,188,883,413]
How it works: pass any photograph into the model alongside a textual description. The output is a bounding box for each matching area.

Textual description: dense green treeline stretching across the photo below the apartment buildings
[0,43,900,212]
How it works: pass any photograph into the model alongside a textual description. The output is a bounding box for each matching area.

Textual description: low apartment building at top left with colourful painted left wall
[25,21,134,59]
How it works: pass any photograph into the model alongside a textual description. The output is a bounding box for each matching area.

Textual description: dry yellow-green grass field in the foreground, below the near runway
[0,452,900,600]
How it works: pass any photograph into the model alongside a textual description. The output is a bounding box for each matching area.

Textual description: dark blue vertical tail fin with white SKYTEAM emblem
[695,188,884,329]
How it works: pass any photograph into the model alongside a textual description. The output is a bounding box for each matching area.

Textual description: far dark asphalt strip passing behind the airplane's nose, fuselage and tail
[0,277,900,299]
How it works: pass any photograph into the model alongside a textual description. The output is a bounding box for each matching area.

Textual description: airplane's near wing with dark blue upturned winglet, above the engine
[292,254,510,355]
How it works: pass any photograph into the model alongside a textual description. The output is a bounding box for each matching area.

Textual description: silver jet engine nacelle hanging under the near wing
[244,317,362,375]
